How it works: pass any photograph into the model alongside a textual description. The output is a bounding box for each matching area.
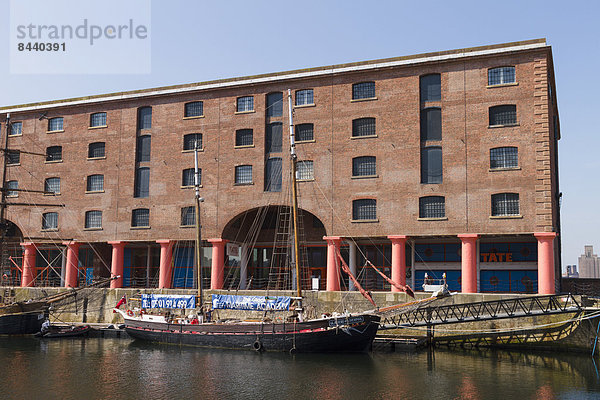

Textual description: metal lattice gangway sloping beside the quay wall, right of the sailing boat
[379,293,584,329]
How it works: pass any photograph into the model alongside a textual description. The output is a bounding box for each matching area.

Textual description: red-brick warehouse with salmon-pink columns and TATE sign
[0,39,561,293]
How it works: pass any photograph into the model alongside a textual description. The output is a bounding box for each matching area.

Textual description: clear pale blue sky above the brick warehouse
[0,0,600,265]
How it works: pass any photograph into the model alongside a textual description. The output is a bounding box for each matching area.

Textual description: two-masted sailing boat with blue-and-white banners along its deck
[114,90,404,353]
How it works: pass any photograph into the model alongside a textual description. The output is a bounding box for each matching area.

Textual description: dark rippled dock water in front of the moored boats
[0,338,600,400]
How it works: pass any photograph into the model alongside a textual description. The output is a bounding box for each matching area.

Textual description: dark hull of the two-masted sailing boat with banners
[125,314,379,353]
